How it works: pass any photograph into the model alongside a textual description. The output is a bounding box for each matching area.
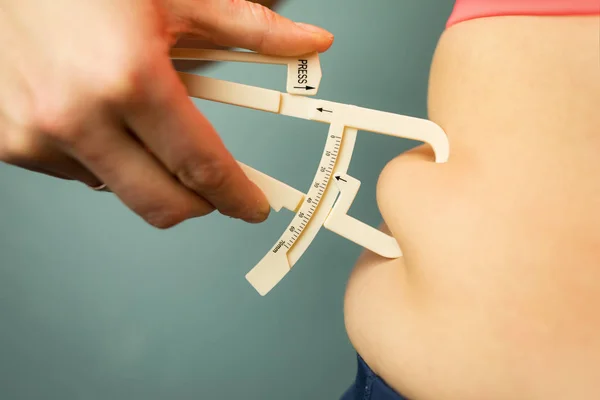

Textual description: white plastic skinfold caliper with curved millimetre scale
[171,49,449,296]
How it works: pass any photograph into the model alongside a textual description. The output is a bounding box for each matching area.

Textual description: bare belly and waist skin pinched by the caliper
[345,16,600,400]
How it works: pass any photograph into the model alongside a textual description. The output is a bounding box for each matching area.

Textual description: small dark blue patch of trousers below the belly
[340,355,408,400]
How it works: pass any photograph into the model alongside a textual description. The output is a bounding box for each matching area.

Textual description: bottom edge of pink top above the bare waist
[446,0,600,27]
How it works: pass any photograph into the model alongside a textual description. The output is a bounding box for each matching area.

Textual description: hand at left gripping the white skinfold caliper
[0,0,333,228]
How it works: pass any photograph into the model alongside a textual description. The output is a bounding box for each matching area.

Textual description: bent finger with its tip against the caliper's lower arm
[124,55,270,222]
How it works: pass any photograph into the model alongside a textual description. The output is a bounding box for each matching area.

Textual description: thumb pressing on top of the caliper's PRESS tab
[177,0,333,56]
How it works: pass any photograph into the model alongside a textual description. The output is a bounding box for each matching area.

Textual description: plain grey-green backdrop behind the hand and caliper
[0,0,452,400]
